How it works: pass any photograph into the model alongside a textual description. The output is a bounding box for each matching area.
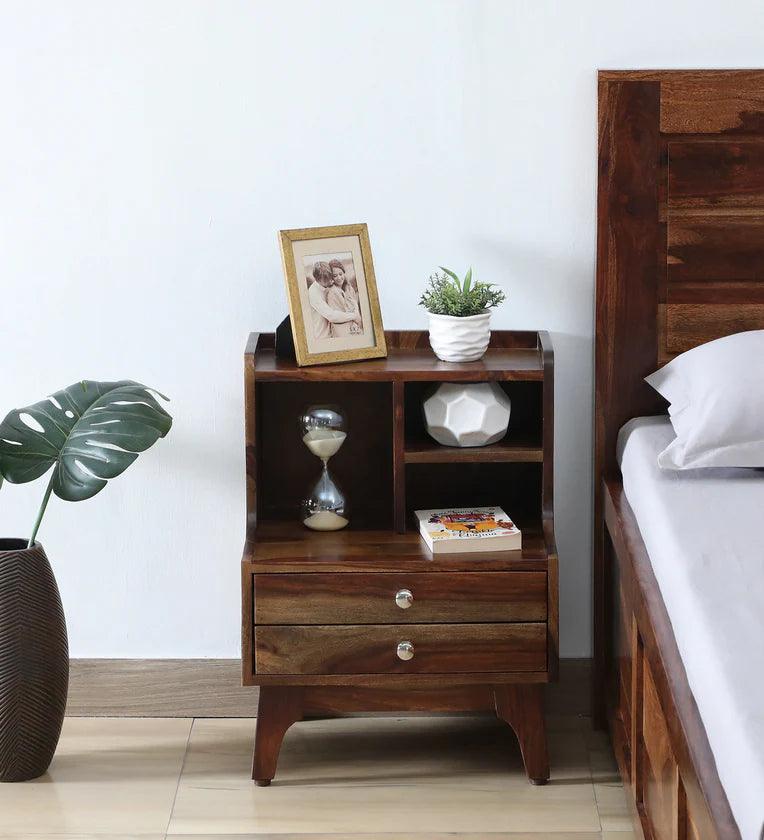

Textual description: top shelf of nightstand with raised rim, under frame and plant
[245,331,546,382]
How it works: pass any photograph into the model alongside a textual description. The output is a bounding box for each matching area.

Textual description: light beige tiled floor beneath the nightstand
[0,717,631,840]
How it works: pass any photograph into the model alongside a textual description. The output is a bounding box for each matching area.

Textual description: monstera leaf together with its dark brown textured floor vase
[0,380,172,782]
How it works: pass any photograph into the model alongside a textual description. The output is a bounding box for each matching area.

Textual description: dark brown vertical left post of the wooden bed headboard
[592,75,663,725]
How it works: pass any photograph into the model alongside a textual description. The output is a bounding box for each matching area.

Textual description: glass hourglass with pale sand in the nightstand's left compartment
[300,405,348,531]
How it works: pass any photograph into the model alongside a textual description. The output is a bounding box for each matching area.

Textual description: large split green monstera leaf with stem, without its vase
[0,380,172,546]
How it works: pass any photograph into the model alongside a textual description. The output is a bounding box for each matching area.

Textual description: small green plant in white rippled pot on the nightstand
[419,266,506,362]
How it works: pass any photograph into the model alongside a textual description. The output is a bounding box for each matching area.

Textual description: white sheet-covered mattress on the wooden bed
[618,417,764,840]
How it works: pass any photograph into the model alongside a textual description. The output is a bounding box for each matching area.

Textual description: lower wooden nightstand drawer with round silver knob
[255,622,547,675]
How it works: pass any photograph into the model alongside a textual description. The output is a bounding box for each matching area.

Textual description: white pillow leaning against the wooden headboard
[645,330,764,470]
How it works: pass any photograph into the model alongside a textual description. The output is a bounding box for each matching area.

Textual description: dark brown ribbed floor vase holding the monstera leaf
[0,539,69,782]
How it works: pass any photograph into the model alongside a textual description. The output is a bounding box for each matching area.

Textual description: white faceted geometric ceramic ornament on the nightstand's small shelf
[422,382,512,446]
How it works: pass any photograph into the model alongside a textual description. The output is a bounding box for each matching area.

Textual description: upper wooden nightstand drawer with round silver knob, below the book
[255,572,547,624]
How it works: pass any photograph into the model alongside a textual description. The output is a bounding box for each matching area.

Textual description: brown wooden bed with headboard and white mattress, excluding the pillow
[593,70,764,840]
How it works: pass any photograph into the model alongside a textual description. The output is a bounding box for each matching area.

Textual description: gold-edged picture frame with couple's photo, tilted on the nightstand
[279,224,387,366]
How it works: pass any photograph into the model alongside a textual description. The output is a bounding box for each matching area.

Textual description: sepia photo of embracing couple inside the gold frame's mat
[303,252,364,339]
